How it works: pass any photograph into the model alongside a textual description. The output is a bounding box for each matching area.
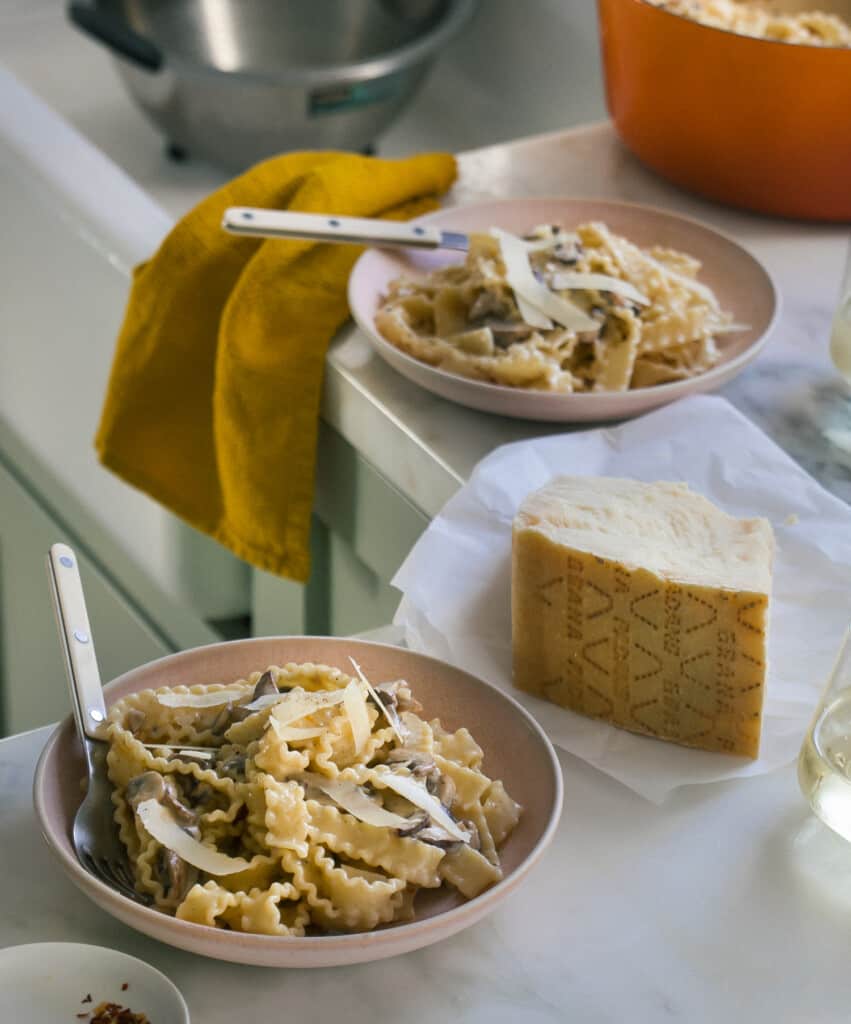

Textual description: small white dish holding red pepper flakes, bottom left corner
[0,942,189,1024]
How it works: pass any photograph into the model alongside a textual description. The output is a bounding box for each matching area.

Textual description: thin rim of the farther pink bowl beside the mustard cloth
[346,195,782,408]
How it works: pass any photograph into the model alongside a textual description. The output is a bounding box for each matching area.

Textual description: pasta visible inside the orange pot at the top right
[649,0,851,46]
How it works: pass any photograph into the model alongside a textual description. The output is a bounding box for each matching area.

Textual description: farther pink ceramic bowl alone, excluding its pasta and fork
[348,198,779,423]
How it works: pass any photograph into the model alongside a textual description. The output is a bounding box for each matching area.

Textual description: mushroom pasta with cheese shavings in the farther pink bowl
[375,223,740,392]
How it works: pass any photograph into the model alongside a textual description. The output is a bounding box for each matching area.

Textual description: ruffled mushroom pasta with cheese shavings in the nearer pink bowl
[107,664,521,936]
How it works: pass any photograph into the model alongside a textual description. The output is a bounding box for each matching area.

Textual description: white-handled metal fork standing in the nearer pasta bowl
[47,544,150,903]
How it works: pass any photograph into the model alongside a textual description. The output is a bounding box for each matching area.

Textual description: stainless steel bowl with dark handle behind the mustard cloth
[68,0,475,170]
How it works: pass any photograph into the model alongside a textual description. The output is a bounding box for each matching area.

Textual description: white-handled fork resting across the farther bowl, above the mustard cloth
[221,206,470,252]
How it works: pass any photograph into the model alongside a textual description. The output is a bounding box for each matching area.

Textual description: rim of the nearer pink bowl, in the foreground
[32,636,564,963]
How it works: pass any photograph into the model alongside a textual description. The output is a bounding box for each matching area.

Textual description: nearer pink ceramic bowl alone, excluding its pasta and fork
[34,637,562,967]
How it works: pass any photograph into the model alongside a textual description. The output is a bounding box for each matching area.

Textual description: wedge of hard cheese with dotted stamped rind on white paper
[511,476,773,758]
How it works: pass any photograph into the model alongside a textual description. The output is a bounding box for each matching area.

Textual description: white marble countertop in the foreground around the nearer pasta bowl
[0,643,851,1024]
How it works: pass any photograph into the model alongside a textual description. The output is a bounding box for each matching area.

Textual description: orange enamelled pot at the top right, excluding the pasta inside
[598,0,851,221]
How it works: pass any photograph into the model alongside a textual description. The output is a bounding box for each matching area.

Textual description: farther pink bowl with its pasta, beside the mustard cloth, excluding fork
[348,198,779,423]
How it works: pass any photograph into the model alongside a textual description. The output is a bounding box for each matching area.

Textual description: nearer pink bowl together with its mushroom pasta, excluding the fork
[34,637,562,967]
